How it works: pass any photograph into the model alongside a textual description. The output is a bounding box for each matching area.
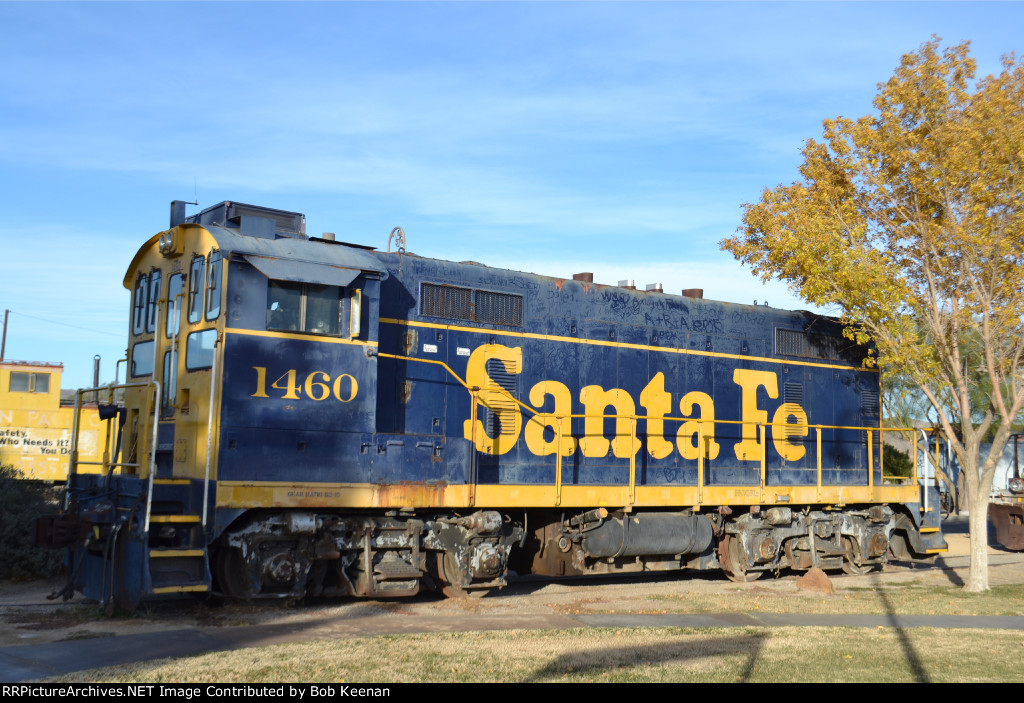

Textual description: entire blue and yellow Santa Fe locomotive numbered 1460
[39,202,945,607]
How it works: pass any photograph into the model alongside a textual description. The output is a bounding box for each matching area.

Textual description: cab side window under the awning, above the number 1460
[266,280,342,336]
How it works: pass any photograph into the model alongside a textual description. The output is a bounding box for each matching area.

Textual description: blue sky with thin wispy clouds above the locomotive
[0,2,1024,387]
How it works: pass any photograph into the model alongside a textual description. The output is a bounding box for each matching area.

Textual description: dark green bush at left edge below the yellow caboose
[0,465,63,579]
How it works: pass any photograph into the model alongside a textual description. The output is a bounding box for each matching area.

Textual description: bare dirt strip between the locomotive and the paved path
[0,516,1024,647]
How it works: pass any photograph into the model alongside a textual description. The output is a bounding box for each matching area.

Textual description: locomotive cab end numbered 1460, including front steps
[50,203,395,607]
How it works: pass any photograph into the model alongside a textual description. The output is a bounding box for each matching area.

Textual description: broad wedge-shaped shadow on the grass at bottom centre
[523,633,768,683]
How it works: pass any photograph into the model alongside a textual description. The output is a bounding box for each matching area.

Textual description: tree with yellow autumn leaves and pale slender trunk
[722,37,1024,591]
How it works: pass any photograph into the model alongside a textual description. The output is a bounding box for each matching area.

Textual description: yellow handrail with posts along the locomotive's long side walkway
[377,352,939,505]
